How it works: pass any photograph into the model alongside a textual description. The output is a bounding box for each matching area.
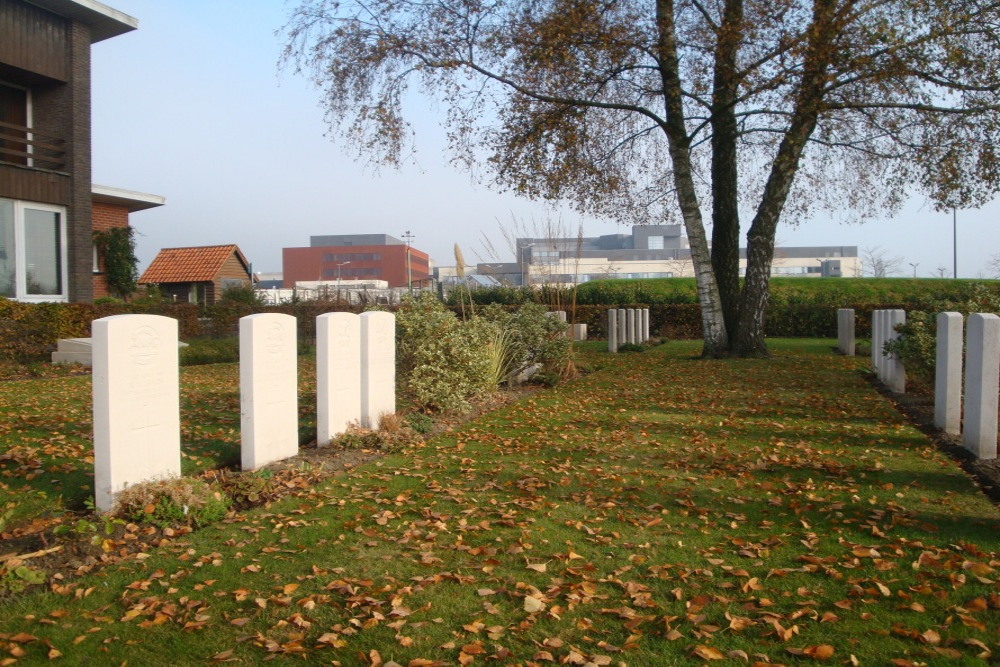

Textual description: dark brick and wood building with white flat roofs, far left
[0,0,163,301]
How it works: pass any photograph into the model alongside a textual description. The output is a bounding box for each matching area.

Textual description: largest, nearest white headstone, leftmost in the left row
[92,315,181,512]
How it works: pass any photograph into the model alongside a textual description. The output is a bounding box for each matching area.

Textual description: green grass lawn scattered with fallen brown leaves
[0,340,1000,667]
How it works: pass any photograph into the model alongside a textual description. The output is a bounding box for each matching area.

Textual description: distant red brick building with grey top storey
[281,234,431,288]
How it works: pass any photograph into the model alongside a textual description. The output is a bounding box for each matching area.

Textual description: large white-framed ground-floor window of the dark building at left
[0,199,67,301]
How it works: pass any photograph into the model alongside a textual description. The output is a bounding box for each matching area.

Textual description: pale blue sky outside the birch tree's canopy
[93,0,1000,277]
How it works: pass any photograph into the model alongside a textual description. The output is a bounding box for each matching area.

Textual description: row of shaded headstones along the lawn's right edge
[837,308,1000,459]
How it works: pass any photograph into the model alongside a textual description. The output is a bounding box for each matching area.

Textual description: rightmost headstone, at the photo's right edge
[962,313,1000,459]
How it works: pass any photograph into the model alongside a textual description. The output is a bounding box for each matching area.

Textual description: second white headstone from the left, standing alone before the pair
[240,313,299,470]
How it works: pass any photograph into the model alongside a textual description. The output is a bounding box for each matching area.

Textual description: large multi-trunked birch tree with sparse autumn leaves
[285,0,1000,356]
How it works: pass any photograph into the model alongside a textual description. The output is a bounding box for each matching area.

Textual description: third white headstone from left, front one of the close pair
[316,313,361,447]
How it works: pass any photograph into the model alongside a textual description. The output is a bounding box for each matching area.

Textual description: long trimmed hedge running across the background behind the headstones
[0,278,1000,361]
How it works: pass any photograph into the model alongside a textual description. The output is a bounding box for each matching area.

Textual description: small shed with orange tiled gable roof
[139,244,253,304]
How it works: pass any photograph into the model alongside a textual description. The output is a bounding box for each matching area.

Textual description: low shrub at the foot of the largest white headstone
[112,477,229,528]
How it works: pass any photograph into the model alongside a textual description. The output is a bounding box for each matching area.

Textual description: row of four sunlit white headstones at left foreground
[92,312,396,511]
